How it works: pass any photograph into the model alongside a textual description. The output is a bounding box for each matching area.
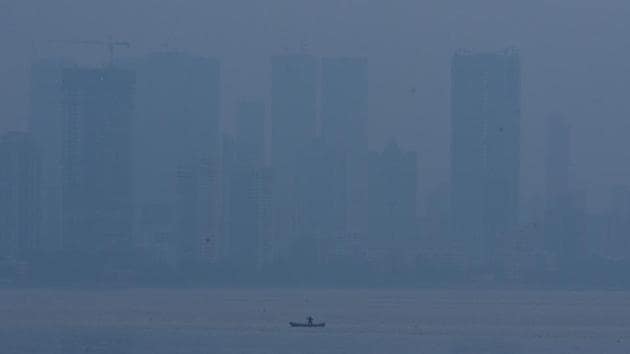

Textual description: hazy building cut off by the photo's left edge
[0,132,41,259]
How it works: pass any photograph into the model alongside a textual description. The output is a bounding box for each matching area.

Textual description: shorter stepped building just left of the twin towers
[223,102,271,271]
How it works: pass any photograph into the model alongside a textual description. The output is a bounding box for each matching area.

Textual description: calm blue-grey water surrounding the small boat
[0,289,630,354]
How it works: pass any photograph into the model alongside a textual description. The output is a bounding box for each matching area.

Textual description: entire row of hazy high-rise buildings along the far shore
[0,49,630,284]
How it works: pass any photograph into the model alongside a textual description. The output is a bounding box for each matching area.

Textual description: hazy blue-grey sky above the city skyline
[0,0,630,209]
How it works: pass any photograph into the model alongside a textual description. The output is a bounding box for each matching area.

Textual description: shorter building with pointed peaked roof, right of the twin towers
[368,141,418,256]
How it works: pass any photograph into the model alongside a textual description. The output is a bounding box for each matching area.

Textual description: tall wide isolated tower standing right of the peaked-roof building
[451,49,521,260]
